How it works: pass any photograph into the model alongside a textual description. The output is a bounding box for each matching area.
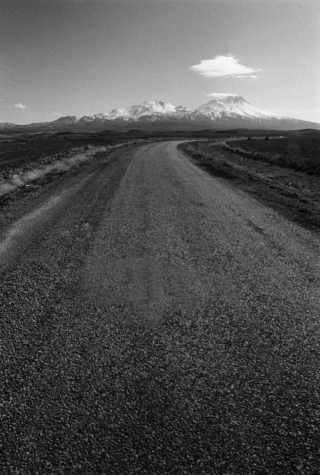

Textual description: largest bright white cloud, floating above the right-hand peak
[190,56,260,79]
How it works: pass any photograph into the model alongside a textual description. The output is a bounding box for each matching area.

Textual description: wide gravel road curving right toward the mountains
[0,142,320,475]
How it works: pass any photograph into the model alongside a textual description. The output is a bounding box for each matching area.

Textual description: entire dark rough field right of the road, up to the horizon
[179,134,320,232]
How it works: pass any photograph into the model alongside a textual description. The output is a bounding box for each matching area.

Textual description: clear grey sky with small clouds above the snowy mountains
[0,0,320,124]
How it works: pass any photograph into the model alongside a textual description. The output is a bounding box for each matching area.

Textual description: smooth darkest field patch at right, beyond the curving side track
[227,132,320,176]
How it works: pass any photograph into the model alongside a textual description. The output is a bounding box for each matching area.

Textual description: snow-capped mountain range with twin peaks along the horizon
[0,93,320,130]
